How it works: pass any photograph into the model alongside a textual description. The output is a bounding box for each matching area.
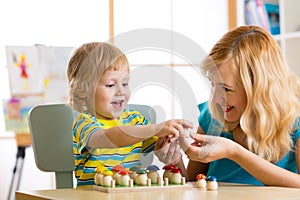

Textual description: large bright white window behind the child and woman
[0,0,228,135]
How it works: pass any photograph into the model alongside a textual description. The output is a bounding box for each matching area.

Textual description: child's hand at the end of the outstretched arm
[155,119,193,141]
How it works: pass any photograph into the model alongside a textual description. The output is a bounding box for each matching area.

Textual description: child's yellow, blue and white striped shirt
[73,110,157,188]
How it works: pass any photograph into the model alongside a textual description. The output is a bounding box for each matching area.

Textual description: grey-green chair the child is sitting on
[28,104,156,189]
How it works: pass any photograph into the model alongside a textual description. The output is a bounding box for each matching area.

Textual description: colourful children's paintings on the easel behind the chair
[2,45,73,133]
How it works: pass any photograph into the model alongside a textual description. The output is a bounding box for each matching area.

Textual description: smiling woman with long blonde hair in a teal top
[180,26,300,188]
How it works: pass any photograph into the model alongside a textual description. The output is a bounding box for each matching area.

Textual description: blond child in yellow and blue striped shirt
[67,42,192,188]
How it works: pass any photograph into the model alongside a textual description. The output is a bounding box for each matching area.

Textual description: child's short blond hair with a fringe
[67,42,129,114]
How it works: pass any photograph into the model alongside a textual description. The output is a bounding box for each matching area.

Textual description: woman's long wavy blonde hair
[202,26,300,162]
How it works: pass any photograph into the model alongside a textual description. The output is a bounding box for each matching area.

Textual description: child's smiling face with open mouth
[95,70,130,119]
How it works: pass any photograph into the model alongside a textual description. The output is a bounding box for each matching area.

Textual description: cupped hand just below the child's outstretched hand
[154,136,182,165]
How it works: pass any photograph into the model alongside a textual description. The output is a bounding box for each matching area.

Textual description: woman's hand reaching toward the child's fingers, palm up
[182,134,238,163]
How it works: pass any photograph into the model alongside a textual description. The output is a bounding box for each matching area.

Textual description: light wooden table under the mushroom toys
[16,183,300,200]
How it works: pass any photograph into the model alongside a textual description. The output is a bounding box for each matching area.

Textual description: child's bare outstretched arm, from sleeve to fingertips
[87,119,192,149]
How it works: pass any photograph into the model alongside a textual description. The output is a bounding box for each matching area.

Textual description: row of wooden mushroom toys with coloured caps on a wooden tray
[94,164,185,188]
